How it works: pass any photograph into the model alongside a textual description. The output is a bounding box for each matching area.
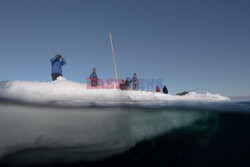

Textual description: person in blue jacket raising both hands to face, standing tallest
[50,54,66,81]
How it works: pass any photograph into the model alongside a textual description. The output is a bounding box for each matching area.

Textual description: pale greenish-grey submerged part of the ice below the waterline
[0,104,209,166]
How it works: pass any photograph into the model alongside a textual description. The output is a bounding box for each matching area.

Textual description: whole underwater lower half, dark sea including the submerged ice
[0,99,250,167]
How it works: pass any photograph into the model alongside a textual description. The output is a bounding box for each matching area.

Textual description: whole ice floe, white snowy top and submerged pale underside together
[0,77,230,166]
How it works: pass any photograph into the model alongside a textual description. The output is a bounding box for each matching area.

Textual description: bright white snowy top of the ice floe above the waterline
[0,77,230,105]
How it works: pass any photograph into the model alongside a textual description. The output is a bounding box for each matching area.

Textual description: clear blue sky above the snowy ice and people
[0,0,250,96]
